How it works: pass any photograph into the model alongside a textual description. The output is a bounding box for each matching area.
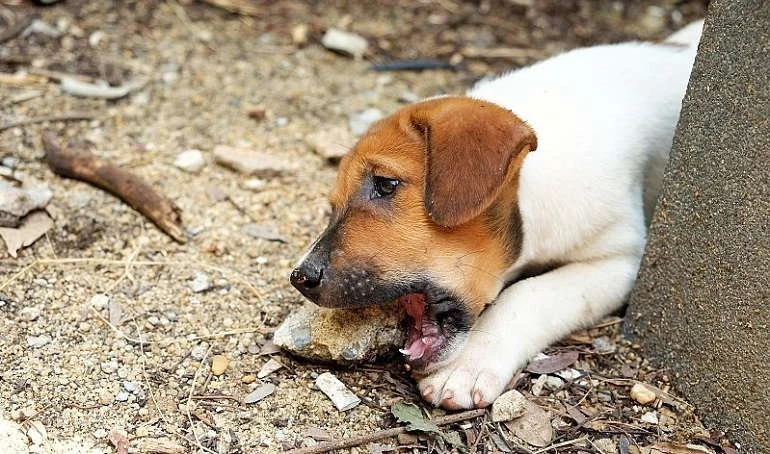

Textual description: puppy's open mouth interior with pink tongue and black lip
[398,293,468,369]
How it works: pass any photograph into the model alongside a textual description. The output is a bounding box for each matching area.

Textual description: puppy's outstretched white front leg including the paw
[419,255,640,409]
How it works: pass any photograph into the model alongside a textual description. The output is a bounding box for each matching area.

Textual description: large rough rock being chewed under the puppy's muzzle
[273,304,405,363]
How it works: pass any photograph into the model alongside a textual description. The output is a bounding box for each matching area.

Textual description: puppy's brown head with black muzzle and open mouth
[291,97,536,369]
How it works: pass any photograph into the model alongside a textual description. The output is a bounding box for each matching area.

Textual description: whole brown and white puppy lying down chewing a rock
[291,23,702,409]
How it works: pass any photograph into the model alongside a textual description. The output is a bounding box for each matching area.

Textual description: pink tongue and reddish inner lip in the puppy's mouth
[398,293,447,366]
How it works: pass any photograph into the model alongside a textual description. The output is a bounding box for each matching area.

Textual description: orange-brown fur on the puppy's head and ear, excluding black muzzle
[329,97,536,316]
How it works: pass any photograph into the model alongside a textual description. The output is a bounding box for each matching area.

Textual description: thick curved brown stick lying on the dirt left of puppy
[43,134,185,243]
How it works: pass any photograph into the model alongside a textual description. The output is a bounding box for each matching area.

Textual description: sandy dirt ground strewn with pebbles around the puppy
[0,0,732,453]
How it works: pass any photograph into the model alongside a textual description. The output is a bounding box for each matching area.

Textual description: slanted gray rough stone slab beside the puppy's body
[627,0,770,453]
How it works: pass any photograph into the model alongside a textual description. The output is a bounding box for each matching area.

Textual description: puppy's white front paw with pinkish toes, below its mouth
[418,352,512,410]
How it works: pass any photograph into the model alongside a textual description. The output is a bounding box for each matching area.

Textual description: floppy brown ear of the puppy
[411,97,537,227]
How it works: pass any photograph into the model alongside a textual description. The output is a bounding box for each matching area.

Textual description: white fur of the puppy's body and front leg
[419,22,702,408]
